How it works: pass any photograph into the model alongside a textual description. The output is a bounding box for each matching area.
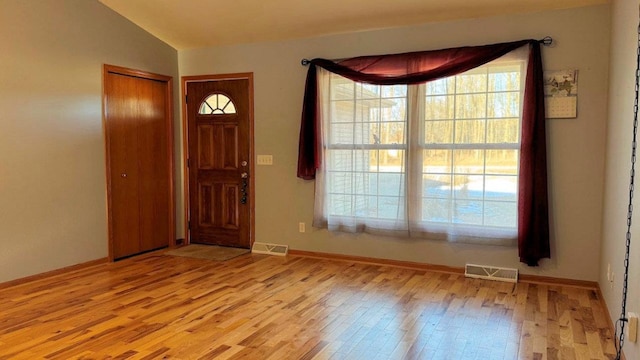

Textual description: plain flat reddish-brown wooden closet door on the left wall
[103,65,175,260]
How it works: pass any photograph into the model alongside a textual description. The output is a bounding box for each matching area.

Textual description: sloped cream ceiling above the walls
[99,0,610,50]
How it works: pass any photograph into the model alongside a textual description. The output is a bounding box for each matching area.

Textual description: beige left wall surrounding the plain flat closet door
[0,0,182,282]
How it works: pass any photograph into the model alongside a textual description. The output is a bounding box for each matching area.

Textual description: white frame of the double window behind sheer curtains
[314,54,526,243]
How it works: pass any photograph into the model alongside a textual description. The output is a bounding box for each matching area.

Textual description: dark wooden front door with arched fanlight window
[183,74,253,248]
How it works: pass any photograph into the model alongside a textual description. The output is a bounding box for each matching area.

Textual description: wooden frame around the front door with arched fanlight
[180,72,256,248]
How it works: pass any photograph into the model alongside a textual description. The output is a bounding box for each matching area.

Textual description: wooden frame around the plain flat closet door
[102,64,176,262]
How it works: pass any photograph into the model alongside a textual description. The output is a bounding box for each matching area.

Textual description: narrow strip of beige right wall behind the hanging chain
[599,0,640,359]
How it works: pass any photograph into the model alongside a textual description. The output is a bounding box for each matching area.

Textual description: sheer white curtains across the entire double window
[314,47,528,244]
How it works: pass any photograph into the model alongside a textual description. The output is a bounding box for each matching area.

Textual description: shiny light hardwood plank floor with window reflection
[0,253,615,360]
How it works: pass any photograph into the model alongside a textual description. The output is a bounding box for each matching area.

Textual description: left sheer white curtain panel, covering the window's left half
[314,69,408,236]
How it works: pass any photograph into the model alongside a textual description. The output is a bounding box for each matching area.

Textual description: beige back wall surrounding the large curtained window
[179,5,609,280]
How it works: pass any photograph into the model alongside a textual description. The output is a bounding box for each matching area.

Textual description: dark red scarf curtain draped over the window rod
[297,39,550,266]
